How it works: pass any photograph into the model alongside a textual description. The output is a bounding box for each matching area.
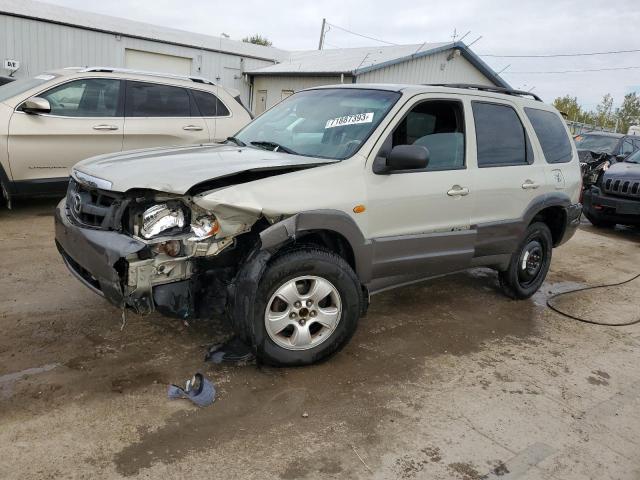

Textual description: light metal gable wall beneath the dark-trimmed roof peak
[357,50,494,85]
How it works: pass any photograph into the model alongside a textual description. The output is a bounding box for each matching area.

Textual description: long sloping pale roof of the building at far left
[0,0,289,60]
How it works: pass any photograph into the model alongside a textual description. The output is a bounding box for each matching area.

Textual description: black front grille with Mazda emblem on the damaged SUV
[67,178,128,230]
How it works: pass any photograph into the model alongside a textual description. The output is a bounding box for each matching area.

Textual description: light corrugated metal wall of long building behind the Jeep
[0,14,273,105]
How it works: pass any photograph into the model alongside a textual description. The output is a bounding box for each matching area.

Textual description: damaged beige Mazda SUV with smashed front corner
[56,85,581,365]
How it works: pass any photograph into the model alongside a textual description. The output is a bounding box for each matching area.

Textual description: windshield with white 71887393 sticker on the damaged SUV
[235,88,400,160]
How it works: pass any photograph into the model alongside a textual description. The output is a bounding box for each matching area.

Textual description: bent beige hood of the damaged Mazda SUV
[74,144,335,195]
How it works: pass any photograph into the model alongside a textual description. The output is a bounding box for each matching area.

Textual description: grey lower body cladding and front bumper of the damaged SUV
[55,201,581,318]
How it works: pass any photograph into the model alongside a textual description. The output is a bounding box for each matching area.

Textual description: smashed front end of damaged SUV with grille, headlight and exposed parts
[60,169,298,318]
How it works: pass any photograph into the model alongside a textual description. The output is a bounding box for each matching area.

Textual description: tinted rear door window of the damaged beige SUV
[471,101,533,168]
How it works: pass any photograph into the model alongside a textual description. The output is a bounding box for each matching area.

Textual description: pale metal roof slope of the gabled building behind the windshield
[248,42,452,75]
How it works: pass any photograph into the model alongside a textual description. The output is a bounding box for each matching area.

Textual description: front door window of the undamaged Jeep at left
[39,78,122,117]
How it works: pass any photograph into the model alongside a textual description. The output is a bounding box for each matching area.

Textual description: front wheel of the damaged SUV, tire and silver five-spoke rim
[250,247,364,366]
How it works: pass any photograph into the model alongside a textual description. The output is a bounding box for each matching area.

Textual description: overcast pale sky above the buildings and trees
[47,0,640,107]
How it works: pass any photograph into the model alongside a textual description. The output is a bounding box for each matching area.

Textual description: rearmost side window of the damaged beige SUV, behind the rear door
[524,108,572,163]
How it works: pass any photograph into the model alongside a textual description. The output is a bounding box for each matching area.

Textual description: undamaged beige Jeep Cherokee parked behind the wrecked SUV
[0,67,251,205]
